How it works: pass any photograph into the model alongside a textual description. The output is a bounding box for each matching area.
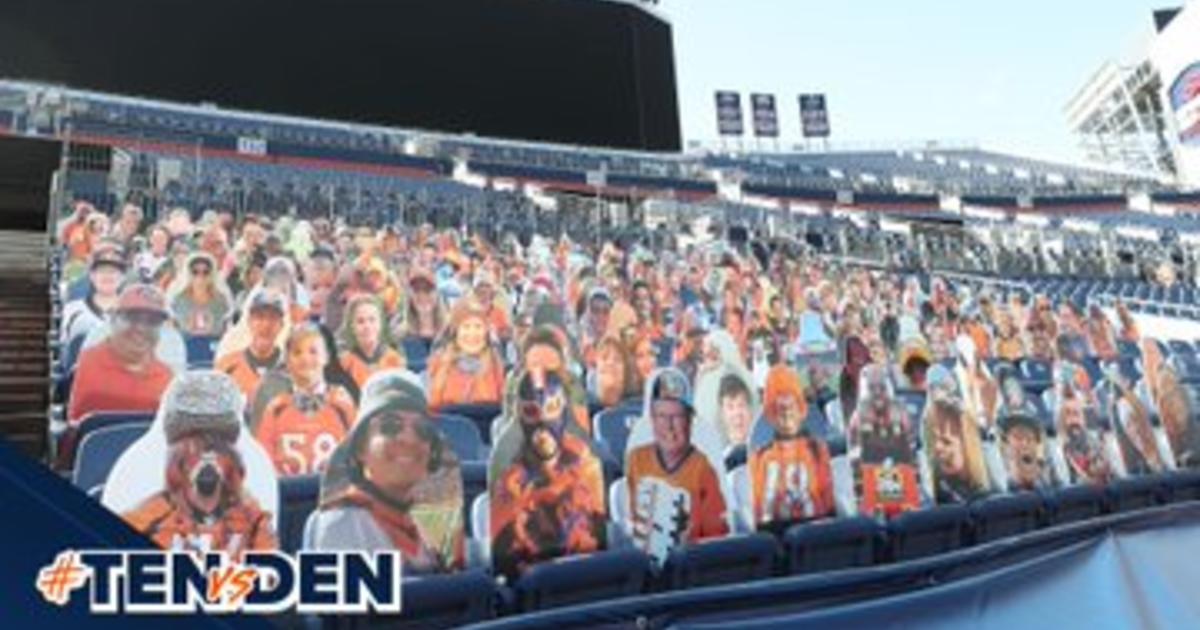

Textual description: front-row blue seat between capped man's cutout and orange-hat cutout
[659,533,779,590]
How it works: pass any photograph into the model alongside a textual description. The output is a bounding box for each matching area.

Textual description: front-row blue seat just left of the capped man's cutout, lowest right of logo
[512,548,650,612]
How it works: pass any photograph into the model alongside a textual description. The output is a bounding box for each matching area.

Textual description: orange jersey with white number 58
[254,388,354,476]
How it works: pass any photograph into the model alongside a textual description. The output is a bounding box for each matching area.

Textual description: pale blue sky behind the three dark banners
[662,0,1166,161]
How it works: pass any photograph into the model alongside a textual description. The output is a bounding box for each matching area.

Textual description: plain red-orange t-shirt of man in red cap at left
[67,341,175,424]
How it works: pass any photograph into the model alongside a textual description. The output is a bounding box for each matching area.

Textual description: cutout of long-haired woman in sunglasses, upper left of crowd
[170,252,233,337]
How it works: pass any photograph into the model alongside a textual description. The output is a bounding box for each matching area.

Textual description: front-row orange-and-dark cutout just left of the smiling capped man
[488,372,608,577]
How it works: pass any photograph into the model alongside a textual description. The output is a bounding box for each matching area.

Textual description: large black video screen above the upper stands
[0,0,679,150]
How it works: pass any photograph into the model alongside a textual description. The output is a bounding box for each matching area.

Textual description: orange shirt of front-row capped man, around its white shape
[625,444,730,542]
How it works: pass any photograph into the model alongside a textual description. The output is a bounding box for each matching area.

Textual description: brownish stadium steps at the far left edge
[0,232,52,458]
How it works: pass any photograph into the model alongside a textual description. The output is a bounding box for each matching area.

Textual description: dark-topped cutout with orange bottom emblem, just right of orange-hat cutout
[847,365,920,517]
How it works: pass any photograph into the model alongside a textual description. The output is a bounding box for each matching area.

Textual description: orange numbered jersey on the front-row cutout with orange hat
[750,438,834,523]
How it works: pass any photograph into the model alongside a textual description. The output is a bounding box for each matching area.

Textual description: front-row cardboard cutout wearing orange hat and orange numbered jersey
[746,365,835,528]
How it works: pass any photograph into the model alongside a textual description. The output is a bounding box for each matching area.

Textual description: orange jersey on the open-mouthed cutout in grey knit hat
[121,491,280,559]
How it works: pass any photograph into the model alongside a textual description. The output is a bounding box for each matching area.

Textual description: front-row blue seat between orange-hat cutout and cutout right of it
[784,516,884,575]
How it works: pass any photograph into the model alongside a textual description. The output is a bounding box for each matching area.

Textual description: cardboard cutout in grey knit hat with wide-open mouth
[101,371,278,558]
